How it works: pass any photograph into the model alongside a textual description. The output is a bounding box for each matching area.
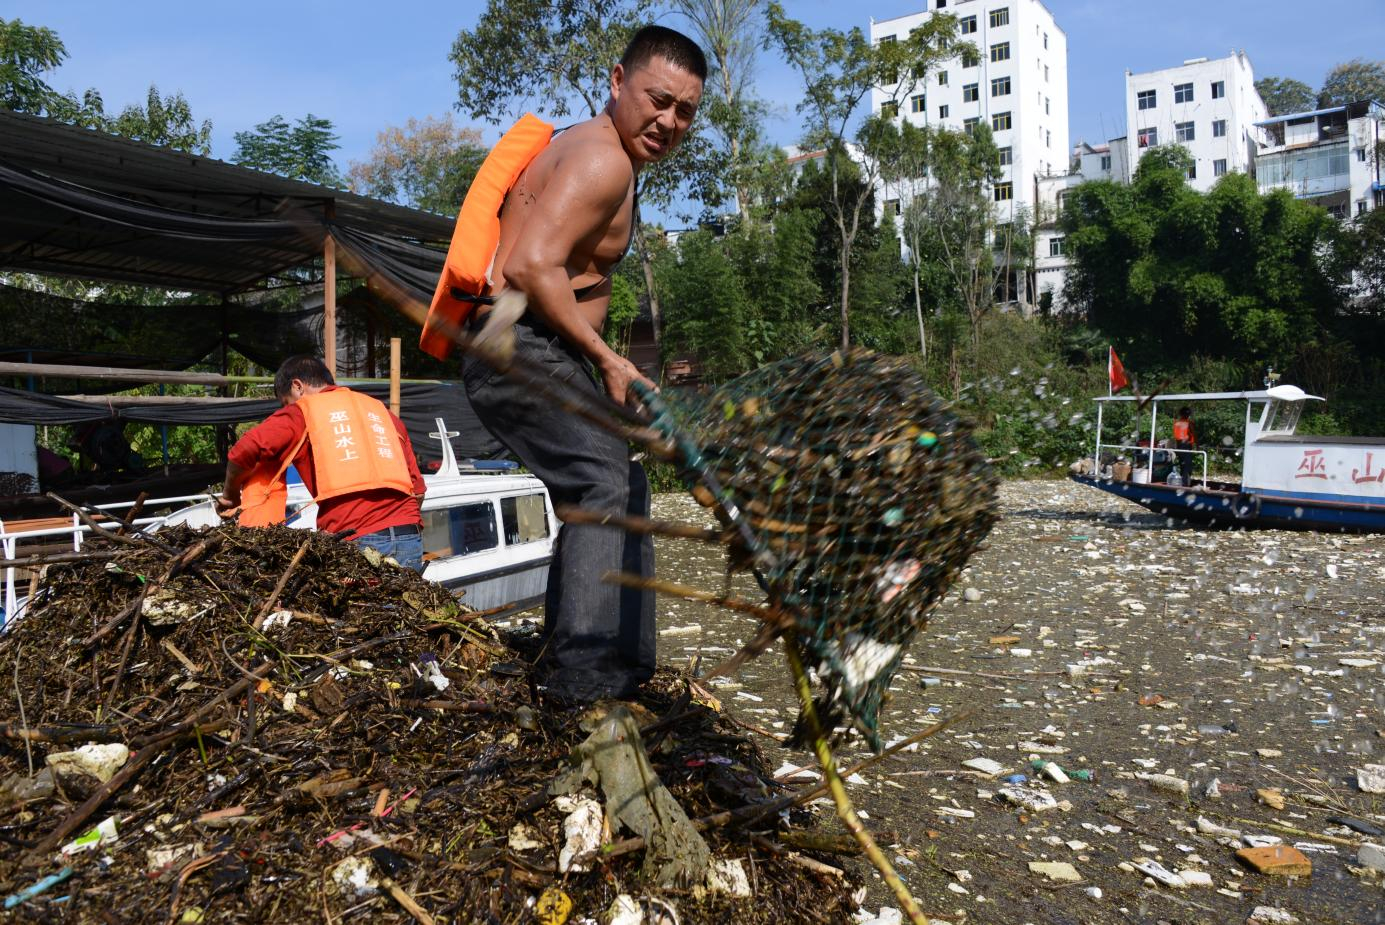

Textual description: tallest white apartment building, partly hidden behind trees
[870,0,1068,240]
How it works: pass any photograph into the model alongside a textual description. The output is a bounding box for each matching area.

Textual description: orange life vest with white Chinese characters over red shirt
[240,389,414,526]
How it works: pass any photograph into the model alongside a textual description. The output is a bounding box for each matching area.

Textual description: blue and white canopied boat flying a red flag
[1071,385,1385,533]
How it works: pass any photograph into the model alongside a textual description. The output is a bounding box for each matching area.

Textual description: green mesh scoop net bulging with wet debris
[642,350,996,751]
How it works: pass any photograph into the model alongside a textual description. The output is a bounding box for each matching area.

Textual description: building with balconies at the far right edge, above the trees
[1255,100,1385,219]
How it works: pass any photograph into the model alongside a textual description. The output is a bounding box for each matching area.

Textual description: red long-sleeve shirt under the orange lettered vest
[227,385,424,539]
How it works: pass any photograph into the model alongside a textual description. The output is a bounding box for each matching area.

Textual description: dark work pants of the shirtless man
[463,318,655,701]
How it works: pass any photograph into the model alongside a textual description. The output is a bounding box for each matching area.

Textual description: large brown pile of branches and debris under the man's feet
[0,526,859,924]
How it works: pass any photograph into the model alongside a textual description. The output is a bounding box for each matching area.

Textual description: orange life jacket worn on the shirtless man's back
[418,112,553,360]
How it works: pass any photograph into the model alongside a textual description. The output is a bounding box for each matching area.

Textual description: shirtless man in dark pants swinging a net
[463,26,706,702]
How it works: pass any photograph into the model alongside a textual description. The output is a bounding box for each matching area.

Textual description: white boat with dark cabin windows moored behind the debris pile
[0,418,558,630]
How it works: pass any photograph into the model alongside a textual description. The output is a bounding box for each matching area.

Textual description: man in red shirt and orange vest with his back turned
[216,356,424,572]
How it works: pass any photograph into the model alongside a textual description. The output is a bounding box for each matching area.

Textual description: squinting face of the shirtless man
[611,57,702,163]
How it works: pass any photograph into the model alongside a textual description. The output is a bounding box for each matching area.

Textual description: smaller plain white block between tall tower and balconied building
[1125,51,1269,192]
